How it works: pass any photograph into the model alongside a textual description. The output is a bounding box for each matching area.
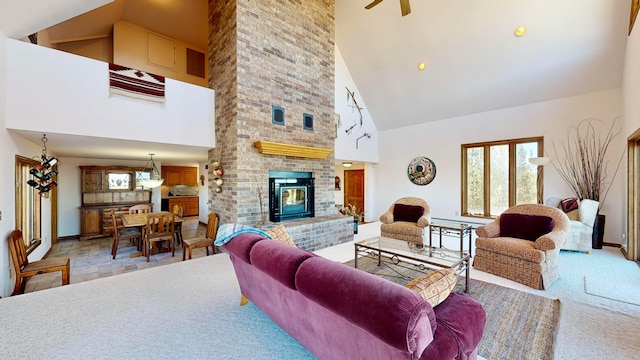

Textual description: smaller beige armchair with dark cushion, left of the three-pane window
[380,197,431,244]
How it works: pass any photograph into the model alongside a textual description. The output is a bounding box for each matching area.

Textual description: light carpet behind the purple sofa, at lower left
[0,254,314,359]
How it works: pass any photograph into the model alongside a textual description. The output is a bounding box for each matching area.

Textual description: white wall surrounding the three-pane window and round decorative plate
[375,89,625,243]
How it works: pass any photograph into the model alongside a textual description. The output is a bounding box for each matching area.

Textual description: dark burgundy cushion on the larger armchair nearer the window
[500,213,555,241]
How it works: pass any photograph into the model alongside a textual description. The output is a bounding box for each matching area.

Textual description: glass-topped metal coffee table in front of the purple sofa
[354,236,471,293]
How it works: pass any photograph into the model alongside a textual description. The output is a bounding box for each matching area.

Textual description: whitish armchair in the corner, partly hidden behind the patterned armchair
[546,198,600,254]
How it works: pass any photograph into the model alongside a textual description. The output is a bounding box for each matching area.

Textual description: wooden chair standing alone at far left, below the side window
[8,230,71,295]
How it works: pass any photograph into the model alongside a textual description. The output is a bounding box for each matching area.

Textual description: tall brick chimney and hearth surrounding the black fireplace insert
[209,0,353,250]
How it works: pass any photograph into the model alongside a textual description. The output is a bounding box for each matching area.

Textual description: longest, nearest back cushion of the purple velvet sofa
[296,256,436,358]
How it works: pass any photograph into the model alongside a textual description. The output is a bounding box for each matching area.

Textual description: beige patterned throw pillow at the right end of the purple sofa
[405,269,458,307]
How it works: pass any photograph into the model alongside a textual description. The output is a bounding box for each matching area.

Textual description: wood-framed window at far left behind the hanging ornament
[16,156,42,247]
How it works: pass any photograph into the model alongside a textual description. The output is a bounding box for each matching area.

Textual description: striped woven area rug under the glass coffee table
[345,258,560,360]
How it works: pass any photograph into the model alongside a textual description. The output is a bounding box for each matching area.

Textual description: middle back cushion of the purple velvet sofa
[249,240,316,290]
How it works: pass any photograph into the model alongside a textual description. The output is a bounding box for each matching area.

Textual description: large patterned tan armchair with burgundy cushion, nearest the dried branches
[473,204,571,289]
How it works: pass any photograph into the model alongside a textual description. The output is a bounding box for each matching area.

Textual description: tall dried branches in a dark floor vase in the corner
[553,119,624,249]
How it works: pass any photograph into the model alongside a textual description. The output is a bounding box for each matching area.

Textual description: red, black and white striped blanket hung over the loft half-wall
[109,63,164,102]
